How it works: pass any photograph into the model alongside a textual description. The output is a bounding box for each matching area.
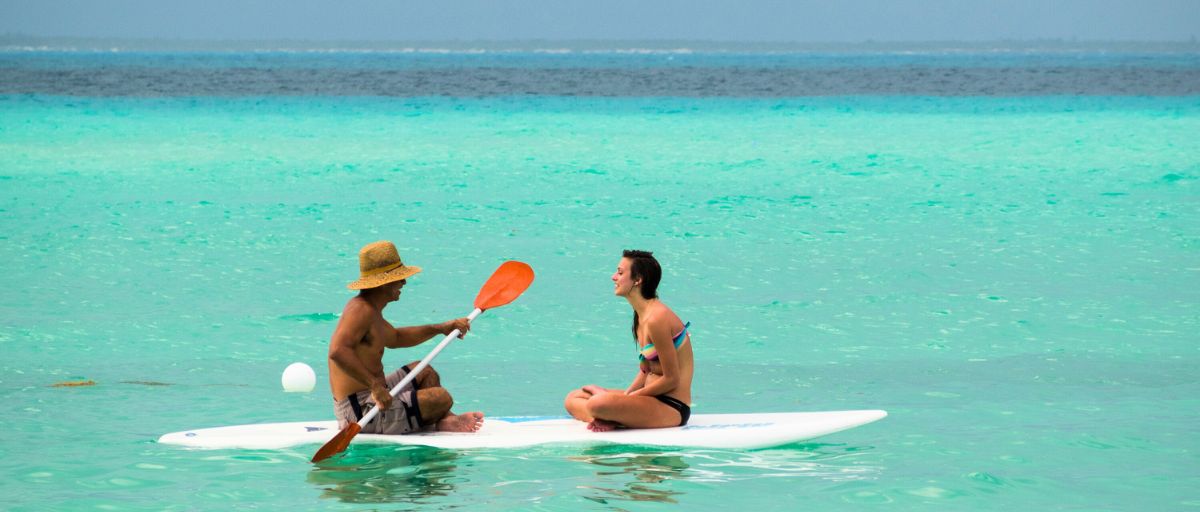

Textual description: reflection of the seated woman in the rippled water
[569,446,689,504]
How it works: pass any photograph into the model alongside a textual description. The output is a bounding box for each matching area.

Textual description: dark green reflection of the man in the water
[308,445,458,504]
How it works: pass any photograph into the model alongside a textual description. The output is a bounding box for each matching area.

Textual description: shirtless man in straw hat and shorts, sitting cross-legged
[329,241,484,434]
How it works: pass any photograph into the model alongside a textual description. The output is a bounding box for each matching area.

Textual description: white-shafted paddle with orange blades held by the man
[312,261,533,463]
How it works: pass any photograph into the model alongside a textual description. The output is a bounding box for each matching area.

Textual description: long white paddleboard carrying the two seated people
[158,410,888,450]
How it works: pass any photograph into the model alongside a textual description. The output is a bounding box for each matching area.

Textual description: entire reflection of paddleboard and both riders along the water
[300,444,883,510]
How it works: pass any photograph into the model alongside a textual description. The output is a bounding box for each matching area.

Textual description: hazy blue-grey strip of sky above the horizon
[0,0,1200,43]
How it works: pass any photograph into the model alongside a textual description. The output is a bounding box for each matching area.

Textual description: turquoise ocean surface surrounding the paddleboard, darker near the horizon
[0,46,1200,511]
